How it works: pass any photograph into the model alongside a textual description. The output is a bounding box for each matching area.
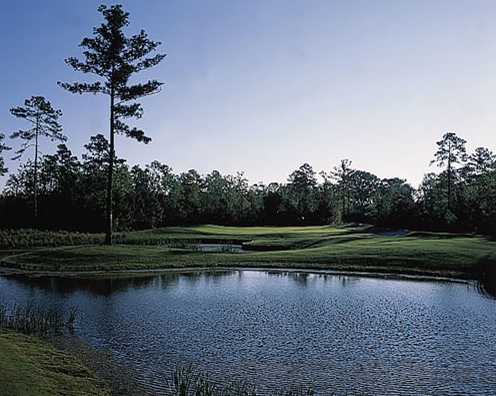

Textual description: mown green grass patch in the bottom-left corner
[0,331,110,396]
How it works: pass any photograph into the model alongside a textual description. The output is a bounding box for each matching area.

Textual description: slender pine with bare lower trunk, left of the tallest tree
[10,96,67,219]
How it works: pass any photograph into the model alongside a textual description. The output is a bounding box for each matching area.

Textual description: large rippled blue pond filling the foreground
[0,270,496,395]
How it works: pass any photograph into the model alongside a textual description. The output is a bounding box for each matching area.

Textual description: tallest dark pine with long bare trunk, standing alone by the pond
[59,5,165,244]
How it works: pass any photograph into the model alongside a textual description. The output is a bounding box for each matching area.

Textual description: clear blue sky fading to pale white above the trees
[0,0,496,185]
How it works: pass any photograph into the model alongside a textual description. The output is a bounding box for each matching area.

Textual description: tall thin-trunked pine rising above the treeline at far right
[431,132,467,210]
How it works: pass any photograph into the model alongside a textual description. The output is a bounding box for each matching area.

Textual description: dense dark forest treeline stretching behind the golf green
[0,133,496,235]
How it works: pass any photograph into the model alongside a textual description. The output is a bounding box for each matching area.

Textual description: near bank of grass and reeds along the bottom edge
[0,304,314,396]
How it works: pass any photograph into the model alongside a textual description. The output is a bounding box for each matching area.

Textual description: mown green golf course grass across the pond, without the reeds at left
[1,226,496,277]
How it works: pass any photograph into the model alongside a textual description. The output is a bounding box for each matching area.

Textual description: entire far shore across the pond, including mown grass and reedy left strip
[0,224,496,282]
